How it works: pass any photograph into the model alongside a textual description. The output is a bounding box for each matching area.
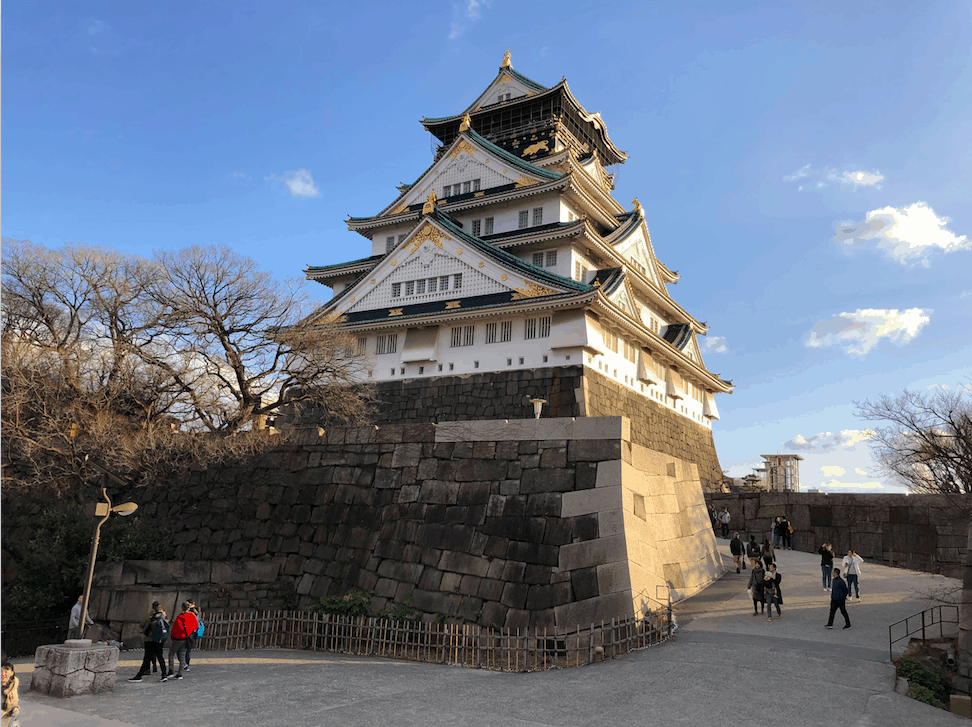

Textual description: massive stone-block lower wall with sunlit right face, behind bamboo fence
[72,417,721,636]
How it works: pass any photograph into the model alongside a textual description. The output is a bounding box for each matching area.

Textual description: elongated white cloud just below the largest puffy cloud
[807,308,932,356]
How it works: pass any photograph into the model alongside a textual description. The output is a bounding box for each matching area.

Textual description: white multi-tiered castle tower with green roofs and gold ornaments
[304,51,732,432]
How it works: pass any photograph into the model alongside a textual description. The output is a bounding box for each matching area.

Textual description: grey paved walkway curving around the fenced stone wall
[11,540,969,727]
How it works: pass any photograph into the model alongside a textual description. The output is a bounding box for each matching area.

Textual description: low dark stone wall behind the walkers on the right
[706,492,969,578]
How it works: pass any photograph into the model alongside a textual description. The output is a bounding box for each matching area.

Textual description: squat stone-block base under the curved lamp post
[30,639,118,697]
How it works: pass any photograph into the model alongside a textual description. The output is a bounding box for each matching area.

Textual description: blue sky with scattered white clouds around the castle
[0,0,972,492]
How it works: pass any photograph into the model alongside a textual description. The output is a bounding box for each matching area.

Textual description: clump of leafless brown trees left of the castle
[0,240,368,490]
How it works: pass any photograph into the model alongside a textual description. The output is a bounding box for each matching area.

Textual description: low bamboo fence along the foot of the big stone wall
[197,610,675,672]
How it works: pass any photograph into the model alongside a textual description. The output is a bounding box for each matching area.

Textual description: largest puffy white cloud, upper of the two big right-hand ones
[834,202,972,266]
